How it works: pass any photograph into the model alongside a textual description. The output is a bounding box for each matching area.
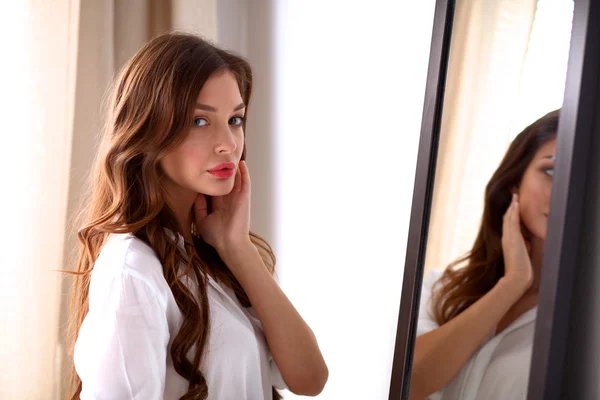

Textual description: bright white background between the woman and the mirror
[217,0,435,400]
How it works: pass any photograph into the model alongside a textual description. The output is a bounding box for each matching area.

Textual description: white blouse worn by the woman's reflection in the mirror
[417,269,537,400]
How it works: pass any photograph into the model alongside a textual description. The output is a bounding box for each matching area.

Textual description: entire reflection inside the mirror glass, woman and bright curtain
[410,0,573,400]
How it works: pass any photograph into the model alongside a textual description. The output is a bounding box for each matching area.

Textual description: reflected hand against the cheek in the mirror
[502,194,533,291]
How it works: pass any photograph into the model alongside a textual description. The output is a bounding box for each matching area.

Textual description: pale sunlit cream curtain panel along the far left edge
[0,0,79,400]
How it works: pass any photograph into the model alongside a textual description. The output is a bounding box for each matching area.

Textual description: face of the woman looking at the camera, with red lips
[160,71,245,199]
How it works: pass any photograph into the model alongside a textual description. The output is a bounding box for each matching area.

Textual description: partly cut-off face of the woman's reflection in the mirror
[518,139,556,240]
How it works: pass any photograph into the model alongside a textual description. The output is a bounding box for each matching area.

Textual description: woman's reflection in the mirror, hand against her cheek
[410,111,559,400]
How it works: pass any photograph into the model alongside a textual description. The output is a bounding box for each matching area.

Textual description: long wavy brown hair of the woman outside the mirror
[69,33,281,400]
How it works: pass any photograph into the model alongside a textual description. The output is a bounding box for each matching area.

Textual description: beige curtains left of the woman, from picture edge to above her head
[0,0,217,400]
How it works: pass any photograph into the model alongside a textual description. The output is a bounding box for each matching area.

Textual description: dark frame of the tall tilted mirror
[389,0,600,400]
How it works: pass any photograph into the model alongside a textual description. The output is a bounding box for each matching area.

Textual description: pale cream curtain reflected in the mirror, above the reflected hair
[425,0,536,270]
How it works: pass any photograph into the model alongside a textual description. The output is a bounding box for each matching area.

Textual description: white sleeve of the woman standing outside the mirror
[74,272,169,400]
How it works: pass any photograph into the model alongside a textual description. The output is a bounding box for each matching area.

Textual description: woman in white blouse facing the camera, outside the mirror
[71,34,328,400]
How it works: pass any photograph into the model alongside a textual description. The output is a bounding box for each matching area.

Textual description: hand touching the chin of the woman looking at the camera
[194,161,251,257]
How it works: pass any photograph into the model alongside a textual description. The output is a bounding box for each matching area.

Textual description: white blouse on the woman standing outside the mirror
[73,233,287,400]
